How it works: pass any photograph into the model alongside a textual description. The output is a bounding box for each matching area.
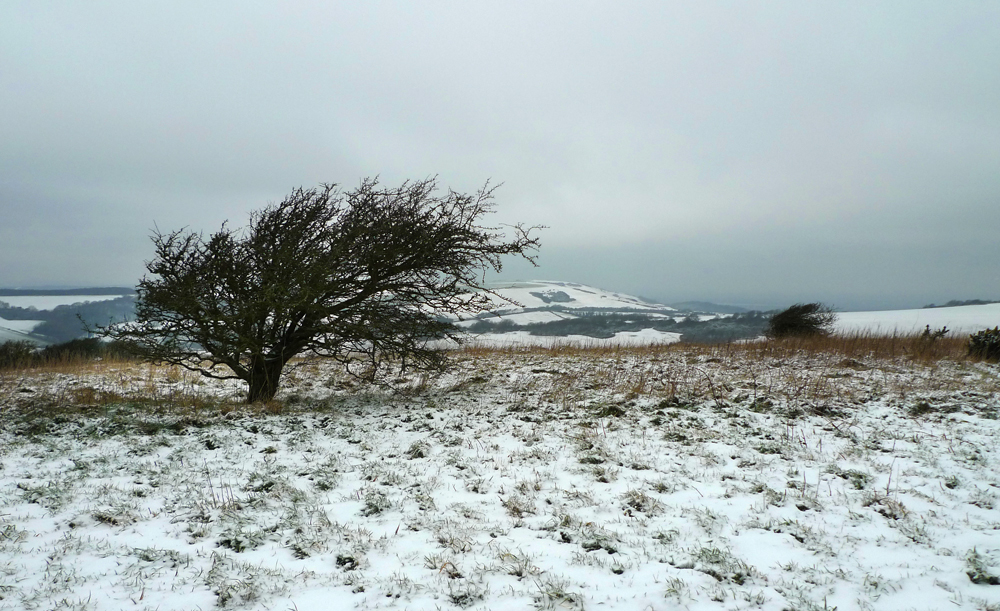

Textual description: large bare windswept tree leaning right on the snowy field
[101,179,539,403]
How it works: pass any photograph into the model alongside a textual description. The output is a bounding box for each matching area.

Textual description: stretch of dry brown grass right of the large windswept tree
[458,333,1000,414]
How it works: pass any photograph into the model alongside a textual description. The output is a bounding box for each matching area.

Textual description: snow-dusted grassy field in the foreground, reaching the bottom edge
[0,346,1000,611]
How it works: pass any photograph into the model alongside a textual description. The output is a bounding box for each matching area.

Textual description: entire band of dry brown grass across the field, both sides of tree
[0,334,1000,413]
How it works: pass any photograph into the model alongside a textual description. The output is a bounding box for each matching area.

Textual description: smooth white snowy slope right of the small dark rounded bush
[836,303,1000,334]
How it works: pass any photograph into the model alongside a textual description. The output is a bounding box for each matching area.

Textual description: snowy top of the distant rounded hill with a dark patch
[482,280,674,312]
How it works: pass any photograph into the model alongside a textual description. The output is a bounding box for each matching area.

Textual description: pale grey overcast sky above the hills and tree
[0,0,1000,309]
